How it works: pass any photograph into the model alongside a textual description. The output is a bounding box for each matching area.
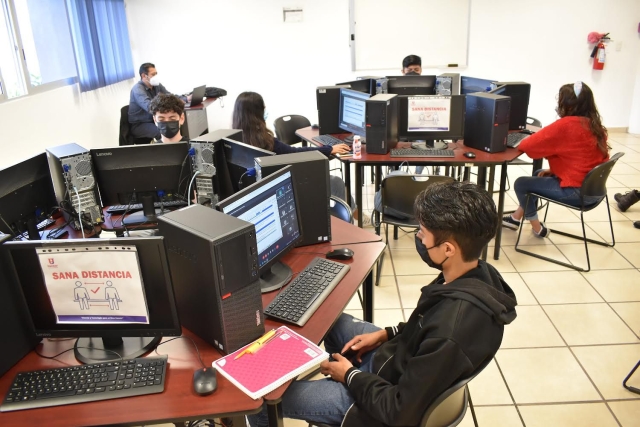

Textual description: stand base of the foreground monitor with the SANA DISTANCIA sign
[73,337,162,363]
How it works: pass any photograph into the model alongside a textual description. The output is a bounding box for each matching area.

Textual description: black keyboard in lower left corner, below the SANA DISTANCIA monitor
[0,356,167,412]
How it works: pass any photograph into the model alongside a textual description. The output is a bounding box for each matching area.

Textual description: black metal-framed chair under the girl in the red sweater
[516,153,624,272]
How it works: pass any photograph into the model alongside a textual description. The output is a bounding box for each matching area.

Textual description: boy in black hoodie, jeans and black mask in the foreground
[249,182,516,427]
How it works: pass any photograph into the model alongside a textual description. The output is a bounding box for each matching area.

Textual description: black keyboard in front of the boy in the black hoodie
[264,257,350,326]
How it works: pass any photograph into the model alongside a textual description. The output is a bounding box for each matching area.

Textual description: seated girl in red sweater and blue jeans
[502,82,611,238]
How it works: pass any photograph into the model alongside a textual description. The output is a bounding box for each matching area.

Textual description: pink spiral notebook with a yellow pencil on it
[212,326,329,399]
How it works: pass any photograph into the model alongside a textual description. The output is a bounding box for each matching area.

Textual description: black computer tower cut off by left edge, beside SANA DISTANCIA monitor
[0,233,40,376]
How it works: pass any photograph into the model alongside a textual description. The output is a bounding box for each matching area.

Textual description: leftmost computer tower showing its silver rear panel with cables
[47,143,104,230]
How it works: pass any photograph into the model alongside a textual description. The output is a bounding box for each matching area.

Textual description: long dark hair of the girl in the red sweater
[556,83,611,155]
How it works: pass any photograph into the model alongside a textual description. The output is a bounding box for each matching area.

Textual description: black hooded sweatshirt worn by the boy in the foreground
[342,261,516,427]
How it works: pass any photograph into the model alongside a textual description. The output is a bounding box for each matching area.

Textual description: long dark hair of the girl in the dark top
[232,92,273,151]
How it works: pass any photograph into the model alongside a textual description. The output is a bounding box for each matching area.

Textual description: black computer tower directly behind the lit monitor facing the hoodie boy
[256,151,331,246]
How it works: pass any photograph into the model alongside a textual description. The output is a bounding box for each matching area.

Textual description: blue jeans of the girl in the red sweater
[513,170,600,221]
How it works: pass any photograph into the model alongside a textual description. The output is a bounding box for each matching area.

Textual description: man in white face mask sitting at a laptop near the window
[129,62,191,141]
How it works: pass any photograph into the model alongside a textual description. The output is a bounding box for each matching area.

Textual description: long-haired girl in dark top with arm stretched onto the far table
[232,92,355,209]
